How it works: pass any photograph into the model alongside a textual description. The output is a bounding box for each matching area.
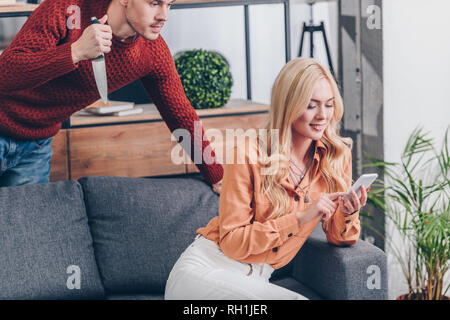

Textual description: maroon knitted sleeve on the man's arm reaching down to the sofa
[142,36,223,184]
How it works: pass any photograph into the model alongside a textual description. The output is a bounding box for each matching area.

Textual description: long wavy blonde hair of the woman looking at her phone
[259,58,352,219]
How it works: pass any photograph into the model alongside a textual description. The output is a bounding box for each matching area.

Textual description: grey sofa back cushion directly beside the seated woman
[79,177,219,295]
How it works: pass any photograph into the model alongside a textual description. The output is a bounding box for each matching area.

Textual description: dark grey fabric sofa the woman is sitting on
[0,176,387,299]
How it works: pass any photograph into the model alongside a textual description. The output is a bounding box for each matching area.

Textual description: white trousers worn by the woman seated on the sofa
[164,235,307,300]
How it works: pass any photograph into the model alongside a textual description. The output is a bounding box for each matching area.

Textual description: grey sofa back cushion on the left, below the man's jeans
[0,181,104,299]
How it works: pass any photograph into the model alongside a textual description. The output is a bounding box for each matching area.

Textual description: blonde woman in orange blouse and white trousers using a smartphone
[165,58,367,299]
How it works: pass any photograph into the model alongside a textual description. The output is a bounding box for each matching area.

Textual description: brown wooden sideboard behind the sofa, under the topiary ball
[50,100,268,181]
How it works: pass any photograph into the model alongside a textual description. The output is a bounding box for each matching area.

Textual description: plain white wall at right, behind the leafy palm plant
[383,0,450,299]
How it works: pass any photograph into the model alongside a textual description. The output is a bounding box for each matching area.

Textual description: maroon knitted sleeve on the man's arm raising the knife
[0,0,77,92]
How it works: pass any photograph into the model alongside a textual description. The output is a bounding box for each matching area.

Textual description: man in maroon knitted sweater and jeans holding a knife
[0,0,223,192]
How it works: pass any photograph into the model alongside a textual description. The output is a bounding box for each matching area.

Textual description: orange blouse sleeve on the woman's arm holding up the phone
[322,149,361,246]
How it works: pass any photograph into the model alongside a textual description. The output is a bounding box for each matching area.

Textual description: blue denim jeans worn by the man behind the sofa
[0,135,53,187]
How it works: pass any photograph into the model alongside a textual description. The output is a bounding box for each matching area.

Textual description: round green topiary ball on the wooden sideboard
[174,49,233,109]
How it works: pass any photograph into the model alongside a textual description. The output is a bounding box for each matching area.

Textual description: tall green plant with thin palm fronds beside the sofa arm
[363,128,450,300]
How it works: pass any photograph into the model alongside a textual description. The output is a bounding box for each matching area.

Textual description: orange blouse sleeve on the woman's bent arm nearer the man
[219,149,299,260]
